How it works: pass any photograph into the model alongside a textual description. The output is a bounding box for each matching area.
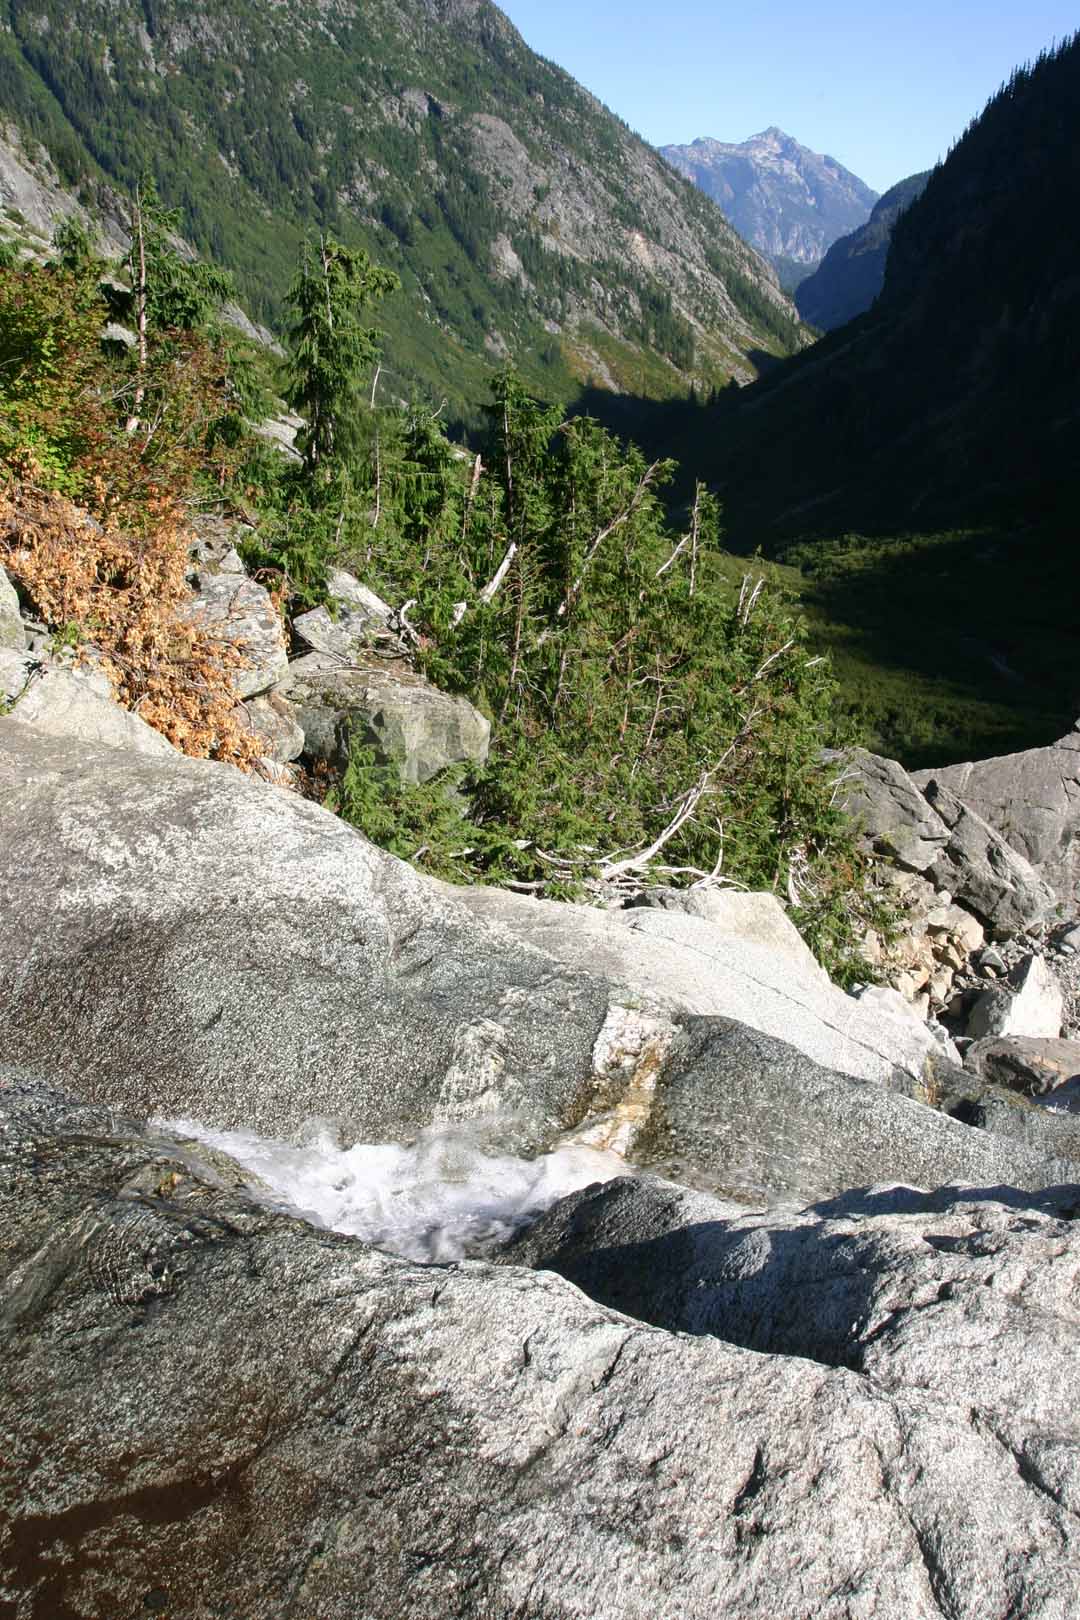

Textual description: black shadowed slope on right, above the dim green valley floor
[716,37,1080,539]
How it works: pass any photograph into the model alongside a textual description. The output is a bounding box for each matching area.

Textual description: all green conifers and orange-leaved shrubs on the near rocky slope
[0,208,880,974]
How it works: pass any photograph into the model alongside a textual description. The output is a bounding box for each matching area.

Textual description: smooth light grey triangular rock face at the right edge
[913,723,1080,914]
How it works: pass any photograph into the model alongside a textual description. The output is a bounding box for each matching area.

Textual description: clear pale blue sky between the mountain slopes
[500,0,1080,191]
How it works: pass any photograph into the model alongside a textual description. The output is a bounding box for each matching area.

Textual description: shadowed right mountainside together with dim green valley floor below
[683,36,1080,765]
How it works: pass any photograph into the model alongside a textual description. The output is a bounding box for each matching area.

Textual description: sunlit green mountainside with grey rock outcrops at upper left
[0,0,803,415]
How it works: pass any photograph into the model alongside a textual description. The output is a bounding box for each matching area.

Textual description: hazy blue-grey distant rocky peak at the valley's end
[661,126,878,264]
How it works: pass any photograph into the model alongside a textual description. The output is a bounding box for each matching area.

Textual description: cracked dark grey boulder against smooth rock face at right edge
[925,779,1056,940]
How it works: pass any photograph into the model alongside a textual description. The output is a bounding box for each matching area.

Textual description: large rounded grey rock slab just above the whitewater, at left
[0,718,609,1145]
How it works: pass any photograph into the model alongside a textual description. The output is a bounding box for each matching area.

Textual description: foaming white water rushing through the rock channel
[154,1119,628,1264]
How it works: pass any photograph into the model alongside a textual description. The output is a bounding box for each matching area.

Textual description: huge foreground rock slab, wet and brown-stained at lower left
[0,1089,1080,1620]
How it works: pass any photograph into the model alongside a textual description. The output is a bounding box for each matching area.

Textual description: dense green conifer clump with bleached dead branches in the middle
[325,371,880,975]
